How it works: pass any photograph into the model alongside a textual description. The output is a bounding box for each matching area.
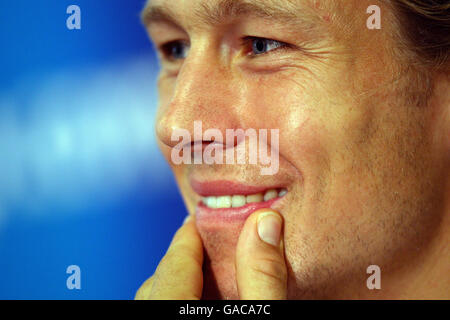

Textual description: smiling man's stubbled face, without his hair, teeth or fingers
[148,0,442,298]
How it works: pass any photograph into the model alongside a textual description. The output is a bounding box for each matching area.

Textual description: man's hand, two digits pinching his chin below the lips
[135,209,287,300]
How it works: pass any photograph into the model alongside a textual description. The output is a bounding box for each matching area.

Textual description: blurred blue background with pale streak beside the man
[0,0,186,299]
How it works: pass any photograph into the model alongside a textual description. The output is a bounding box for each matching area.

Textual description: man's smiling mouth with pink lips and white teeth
[191,181,288,223]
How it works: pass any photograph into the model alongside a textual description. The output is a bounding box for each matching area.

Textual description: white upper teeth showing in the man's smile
[202,189,287,209]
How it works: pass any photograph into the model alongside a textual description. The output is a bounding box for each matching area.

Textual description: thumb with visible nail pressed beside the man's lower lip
[236,209,287,300]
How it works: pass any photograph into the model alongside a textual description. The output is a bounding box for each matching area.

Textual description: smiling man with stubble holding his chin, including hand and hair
[137,0,450,299]
